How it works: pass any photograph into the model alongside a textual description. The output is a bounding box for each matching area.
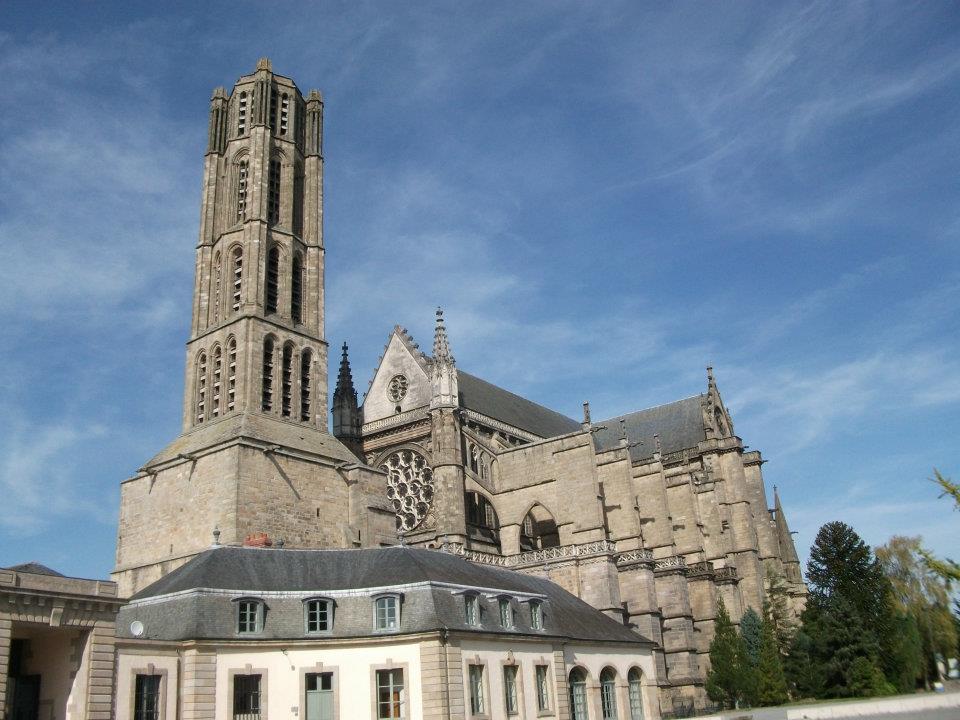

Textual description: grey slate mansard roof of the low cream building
[118,546,649,643]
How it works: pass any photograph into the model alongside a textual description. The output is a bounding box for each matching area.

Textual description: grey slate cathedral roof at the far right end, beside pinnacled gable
[594,395,706,461]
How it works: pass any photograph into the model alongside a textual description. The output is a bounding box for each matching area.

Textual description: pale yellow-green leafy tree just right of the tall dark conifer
[877,535,957,687]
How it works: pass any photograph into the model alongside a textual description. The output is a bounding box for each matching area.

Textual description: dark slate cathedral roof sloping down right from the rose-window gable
[457,369,580,438]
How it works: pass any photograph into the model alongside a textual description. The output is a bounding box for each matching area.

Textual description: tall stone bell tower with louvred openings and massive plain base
[114,59,396,594]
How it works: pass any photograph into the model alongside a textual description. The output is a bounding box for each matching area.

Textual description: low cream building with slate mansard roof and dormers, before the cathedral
[110,546,659,720]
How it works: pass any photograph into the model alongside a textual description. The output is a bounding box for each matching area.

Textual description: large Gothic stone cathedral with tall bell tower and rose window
[107,60,806,717]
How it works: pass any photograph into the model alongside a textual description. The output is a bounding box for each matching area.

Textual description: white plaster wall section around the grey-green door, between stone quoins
[215,642,423,720]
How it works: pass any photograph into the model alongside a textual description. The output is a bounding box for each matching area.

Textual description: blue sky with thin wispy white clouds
[0,0,960,577]
